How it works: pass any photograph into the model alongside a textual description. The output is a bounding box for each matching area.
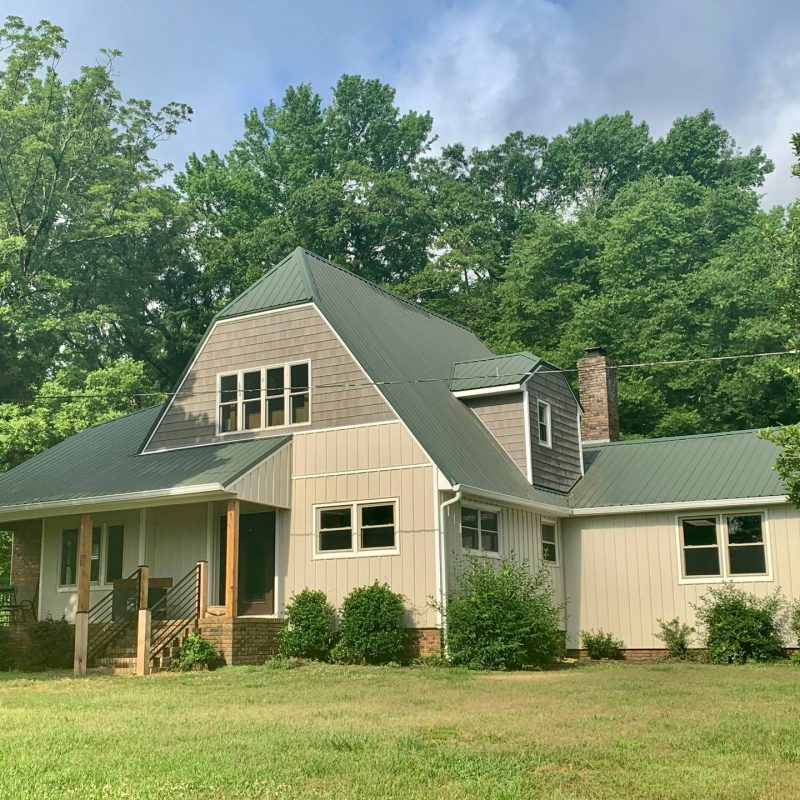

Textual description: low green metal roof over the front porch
[0,406,291,515]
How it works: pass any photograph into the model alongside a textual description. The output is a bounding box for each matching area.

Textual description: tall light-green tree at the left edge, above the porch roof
[0,17,197,400]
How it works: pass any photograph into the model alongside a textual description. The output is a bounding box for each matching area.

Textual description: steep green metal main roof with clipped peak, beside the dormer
[212,248,566,507]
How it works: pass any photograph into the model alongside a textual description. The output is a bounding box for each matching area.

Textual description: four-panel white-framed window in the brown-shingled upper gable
[219,361,311,433]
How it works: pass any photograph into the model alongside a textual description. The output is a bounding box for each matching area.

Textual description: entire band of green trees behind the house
[0,17,800,488]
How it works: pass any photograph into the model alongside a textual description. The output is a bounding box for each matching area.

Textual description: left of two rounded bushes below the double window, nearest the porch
[278,589,336,661]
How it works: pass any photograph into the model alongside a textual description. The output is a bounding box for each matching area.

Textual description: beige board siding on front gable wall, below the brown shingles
[282,422,437,627]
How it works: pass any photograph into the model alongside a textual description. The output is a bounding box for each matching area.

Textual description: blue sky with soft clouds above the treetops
[6,0,800,205]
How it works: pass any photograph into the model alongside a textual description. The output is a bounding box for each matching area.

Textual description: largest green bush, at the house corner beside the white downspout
[440,555,563,669]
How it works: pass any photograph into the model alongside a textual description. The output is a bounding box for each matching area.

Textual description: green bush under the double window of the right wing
[695,584,785,664]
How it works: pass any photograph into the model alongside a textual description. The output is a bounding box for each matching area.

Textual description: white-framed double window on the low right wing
[680,514,767,578]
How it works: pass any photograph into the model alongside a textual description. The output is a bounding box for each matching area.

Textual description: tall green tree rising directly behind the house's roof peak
[176,75,432,298]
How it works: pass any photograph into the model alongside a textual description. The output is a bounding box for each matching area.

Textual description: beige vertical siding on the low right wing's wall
[563,505,800,649]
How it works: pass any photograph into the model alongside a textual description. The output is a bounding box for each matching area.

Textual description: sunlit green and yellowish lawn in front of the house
[0,664,800,800]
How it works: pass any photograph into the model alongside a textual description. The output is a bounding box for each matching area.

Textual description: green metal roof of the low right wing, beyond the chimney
[569,431,786,508]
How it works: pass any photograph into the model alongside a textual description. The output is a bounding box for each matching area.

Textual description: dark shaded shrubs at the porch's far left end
[0,616,75,672]
